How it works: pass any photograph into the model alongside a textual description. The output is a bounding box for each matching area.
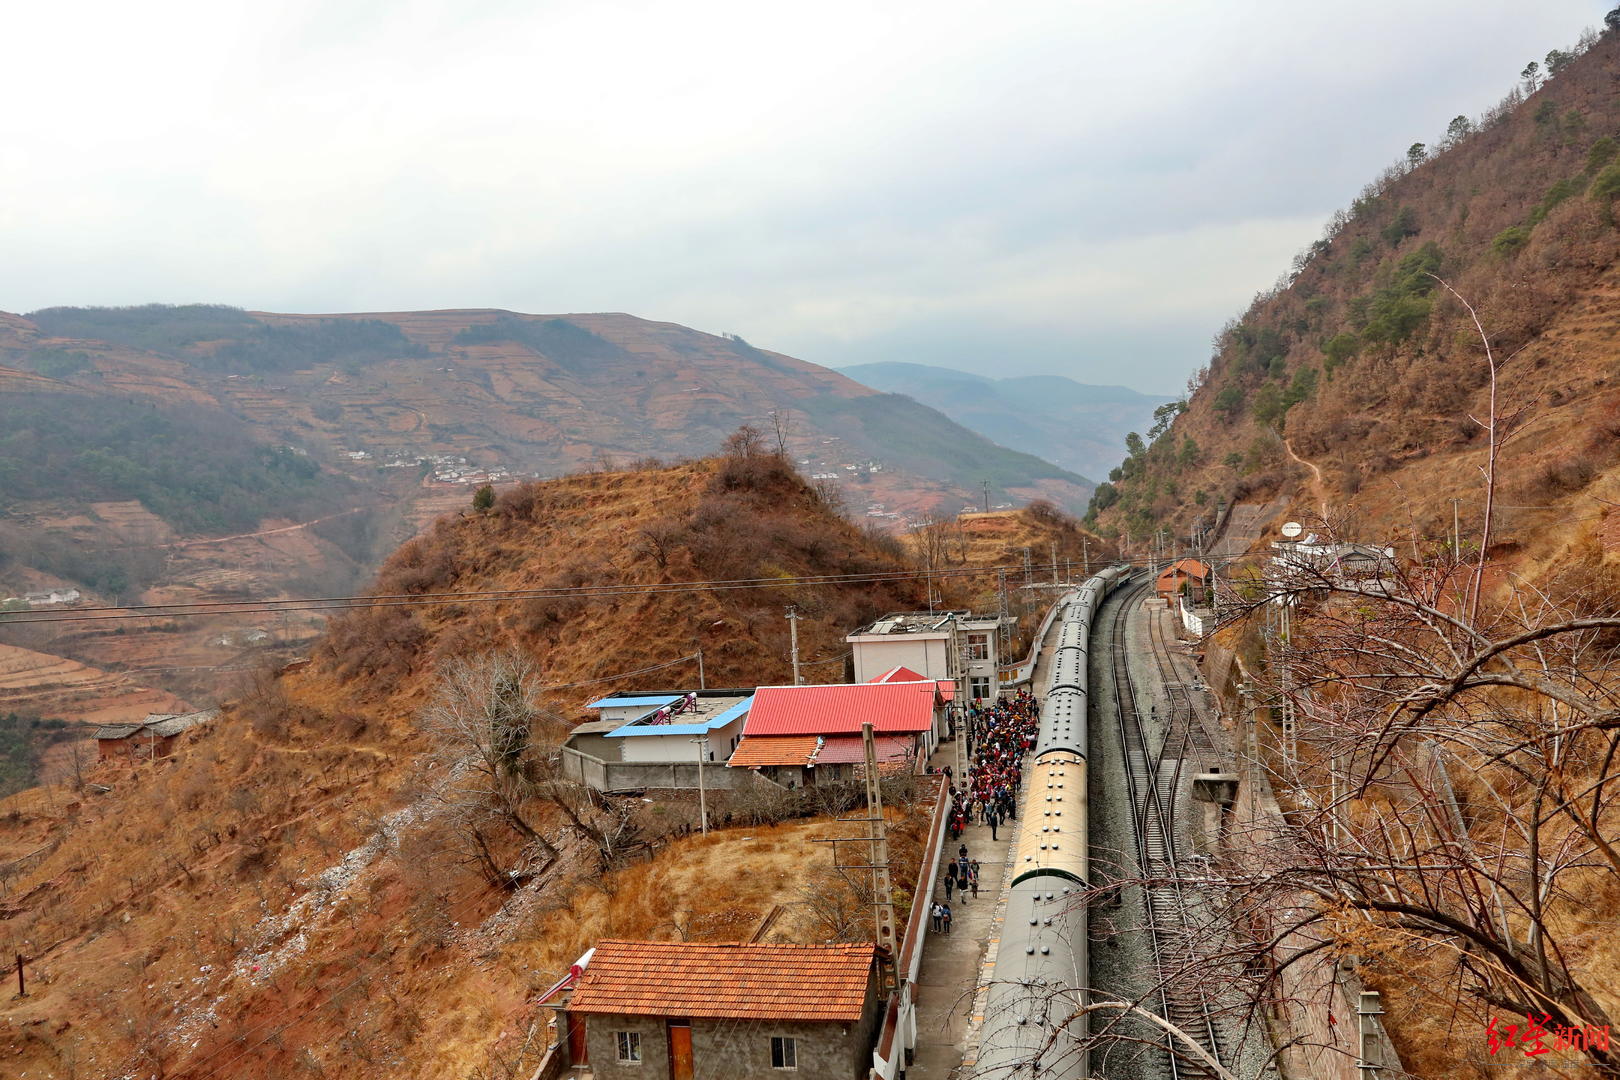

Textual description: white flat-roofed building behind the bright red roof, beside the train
[844,612,1003,701]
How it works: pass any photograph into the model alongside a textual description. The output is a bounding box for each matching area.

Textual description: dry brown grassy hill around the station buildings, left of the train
[0,450,946,1080]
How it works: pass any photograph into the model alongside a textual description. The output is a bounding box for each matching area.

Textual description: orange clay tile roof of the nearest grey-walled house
[569,941,875,1023]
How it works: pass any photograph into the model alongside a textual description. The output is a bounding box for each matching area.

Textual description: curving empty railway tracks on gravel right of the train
[1110,585,1225,1080]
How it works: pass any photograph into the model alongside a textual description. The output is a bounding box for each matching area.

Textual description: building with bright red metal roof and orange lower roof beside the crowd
[727,678,944,787]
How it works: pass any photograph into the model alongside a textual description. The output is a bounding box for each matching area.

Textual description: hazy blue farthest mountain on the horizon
[839,363,1173,479]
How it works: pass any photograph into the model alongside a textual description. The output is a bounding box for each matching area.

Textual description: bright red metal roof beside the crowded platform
[742,678,943,735]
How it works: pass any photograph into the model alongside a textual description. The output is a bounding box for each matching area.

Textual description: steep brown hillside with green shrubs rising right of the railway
[1094,23,1620,566]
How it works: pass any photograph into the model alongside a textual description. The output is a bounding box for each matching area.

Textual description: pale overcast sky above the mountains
[0,0,1609,392]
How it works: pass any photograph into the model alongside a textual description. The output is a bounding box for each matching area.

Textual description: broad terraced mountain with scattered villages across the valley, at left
[0,308,1090,744]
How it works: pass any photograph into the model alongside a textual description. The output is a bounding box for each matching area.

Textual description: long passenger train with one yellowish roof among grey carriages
[975,567,1131,1080]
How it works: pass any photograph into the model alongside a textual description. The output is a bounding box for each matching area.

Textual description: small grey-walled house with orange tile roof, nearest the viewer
[564,941,883,1080]
